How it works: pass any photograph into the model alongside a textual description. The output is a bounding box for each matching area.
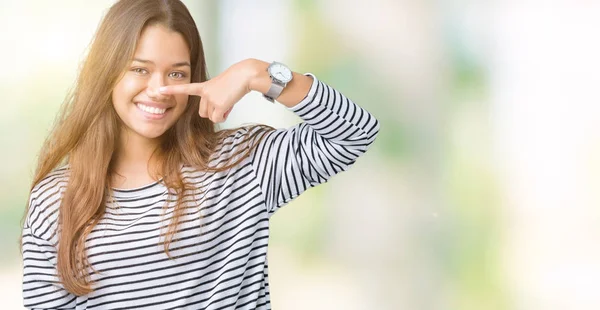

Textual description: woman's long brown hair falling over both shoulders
[25,0,273,295]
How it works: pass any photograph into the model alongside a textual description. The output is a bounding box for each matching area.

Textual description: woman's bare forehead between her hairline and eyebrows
[134,25,190,64]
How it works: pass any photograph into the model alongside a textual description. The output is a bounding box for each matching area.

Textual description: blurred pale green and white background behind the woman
[0,0,600,310]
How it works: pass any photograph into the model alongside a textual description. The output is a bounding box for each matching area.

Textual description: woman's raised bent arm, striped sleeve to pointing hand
[160,59,379,213]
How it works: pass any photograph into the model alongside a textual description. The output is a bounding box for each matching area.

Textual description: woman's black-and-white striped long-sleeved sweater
[22,76,379,309]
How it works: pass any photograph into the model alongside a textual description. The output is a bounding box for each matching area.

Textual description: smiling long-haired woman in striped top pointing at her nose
[22,0,379,309]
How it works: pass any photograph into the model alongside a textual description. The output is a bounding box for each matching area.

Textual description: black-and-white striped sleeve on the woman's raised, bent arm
[251,73,379,215]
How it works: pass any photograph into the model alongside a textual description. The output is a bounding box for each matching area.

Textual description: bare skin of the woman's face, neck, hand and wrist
[112,25,312,189]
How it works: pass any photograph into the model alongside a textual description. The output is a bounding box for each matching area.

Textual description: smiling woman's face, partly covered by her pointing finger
[112,25,191,139]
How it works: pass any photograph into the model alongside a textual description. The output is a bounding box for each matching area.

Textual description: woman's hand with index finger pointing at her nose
[159,61,253,123]
